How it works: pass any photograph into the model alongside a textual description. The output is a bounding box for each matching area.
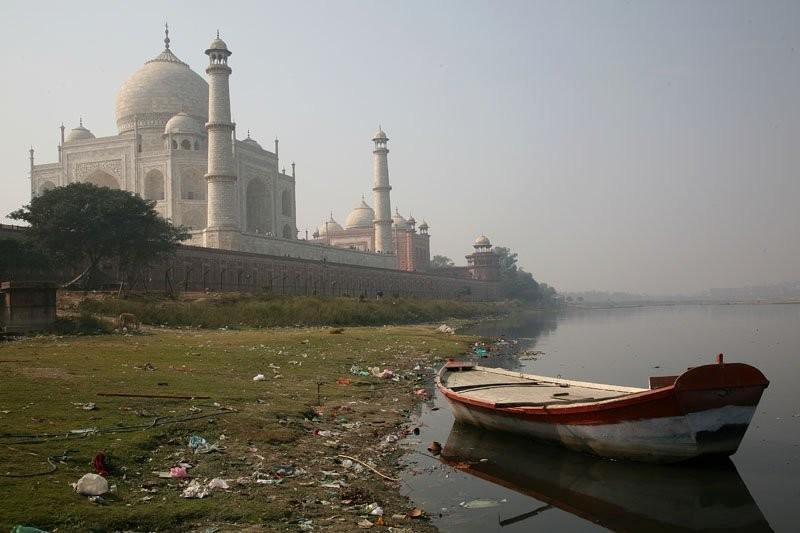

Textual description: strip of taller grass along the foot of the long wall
[79,295,505,328]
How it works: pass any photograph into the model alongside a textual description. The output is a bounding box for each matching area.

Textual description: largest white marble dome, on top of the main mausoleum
[115,48,208,133]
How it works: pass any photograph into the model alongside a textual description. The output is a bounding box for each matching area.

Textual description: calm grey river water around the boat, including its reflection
[405,305,800,532]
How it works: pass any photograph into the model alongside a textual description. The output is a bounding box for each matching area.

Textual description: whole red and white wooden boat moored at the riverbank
[436,354,769,463]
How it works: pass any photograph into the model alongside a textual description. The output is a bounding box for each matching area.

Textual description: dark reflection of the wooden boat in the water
[441,424,772,532]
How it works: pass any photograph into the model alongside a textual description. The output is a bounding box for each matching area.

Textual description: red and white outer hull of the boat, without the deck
[437,363,769,462]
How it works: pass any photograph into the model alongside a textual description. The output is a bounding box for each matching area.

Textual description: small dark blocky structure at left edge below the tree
[0,281,58,333]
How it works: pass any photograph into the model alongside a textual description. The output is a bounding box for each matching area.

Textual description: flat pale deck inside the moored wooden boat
[441,366,647,408]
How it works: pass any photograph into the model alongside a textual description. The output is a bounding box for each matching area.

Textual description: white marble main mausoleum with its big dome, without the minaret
[31,29,297,240]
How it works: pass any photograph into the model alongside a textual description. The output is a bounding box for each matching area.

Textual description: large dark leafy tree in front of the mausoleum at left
[9,183,188,286]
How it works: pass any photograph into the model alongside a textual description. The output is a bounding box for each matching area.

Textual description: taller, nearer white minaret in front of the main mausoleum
[205,32,240,250]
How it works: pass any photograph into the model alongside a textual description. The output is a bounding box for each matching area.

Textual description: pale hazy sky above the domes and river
[0,0,800,293]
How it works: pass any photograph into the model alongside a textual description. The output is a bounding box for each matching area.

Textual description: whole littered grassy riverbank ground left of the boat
[0,326,471,533]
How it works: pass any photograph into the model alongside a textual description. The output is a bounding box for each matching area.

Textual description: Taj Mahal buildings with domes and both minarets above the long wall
[30,27,489,277]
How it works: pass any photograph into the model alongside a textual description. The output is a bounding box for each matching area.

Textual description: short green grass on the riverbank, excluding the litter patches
[0,327,465,531]
